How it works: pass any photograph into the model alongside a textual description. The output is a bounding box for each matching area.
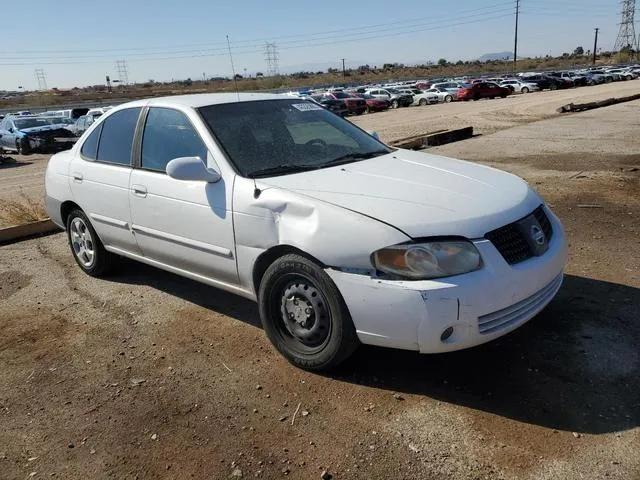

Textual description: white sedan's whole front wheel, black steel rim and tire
[258,254,359,371]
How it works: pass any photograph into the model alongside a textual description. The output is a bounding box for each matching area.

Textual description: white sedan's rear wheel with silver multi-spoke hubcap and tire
[66,209,114,277]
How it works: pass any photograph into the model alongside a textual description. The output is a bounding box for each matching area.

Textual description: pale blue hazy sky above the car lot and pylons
[0,0,620,90]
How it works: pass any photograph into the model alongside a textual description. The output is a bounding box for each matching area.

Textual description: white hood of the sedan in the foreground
[260,150,542,238]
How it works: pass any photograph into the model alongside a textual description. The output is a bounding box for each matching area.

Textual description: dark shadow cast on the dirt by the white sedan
[110,261,640,434]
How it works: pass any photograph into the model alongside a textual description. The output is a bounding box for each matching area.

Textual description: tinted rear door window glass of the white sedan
[97,108,140,165]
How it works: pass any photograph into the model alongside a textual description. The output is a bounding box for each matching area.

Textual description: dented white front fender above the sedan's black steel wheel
[233,177,411,290]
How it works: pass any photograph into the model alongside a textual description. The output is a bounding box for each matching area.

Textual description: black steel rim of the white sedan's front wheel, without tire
[280,280,330,347]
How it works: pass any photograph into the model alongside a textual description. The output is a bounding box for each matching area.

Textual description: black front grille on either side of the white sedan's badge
[485,205,553,265]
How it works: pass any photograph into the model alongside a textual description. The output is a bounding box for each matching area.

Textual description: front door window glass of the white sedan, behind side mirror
[142,108,207,172]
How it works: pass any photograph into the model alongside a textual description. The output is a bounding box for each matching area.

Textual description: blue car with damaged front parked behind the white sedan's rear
[0,115,74,154]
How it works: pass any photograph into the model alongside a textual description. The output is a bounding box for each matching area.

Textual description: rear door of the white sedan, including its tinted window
[69,108,141,253]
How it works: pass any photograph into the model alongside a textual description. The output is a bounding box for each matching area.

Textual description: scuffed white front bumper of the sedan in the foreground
[327,209,567,353]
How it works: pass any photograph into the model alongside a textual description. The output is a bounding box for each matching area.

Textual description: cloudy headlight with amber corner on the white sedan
[372,240,482,280]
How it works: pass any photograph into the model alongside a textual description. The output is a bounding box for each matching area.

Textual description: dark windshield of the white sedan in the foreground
[199,99,391,178]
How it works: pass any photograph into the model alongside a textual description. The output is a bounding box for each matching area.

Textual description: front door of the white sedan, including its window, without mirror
[129,107,238,284]
